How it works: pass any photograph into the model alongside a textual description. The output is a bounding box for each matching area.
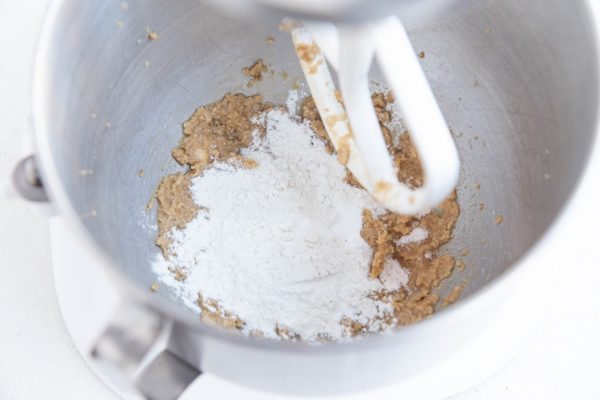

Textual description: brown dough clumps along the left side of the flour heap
[155,93,273,328]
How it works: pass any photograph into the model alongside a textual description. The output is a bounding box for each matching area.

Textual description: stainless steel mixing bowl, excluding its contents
[29,0,598,393]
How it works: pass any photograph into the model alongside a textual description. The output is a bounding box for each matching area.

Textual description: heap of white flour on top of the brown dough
[153,100,408,342]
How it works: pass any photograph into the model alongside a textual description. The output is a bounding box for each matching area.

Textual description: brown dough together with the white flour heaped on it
[153,92,459,342]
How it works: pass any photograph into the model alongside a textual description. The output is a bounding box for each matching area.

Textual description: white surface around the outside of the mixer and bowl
[0,0,600,399]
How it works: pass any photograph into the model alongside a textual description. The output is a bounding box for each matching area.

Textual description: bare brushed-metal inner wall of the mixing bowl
[38,0,597,326]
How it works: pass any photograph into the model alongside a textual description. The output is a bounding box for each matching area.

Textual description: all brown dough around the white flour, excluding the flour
[155,90,460,340]
